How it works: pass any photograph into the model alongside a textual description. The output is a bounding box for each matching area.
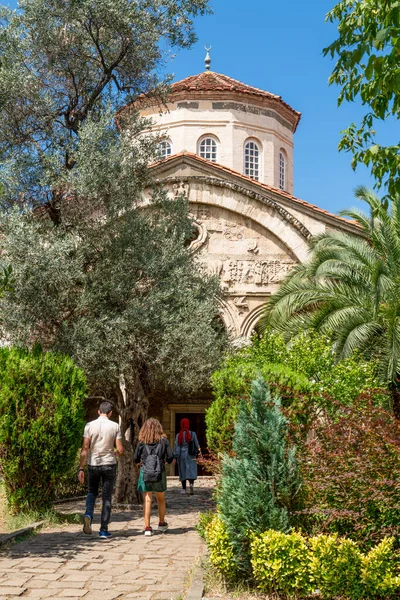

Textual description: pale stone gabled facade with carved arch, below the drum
[146,153,356,339]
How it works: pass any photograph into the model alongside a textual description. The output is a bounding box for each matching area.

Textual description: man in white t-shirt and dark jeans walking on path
[78,402,124,540]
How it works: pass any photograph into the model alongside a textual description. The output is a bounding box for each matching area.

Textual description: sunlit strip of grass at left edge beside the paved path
[0,483,81,534]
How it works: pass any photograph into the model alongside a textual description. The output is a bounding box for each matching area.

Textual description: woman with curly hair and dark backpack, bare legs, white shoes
[135,419,174,535]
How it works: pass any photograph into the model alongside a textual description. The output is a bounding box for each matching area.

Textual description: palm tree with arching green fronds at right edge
[264,186,400,404]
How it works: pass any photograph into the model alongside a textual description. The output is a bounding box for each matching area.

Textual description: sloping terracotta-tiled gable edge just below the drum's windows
[151,150,360,230]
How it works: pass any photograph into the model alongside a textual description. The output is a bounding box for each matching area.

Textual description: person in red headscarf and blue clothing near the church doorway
[174,419,200,495]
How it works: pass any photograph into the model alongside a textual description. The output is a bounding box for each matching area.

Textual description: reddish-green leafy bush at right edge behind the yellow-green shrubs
[299,398,400,551]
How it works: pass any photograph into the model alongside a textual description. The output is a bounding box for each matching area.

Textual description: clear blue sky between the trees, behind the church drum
[5,0,398,212]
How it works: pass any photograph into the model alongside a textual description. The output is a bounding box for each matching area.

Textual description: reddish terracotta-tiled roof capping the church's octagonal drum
[119,71,301,131]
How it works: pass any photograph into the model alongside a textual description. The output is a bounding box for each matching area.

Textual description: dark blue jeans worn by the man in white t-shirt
[85,465,117,531]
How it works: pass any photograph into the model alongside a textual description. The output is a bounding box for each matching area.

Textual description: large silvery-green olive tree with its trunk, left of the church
[0,0,225,502]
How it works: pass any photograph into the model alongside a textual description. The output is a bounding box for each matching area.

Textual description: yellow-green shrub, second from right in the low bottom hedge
[310,535,365,600]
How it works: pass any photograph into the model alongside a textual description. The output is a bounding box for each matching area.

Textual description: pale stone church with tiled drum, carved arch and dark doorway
[122,53,357,460]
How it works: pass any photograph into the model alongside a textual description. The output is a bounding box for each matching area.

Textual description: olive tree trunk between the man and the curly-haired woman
[114,375,149,504]
